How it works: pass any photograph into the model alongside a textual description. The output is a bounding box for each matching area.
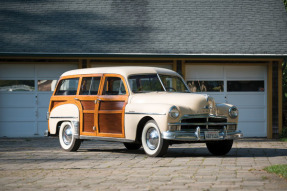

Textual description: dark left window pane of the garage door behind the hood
[187,81,224,92]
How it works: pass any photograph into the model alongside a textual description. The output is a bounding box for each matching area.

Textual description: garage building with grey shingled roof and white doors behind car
[0,0,287,138]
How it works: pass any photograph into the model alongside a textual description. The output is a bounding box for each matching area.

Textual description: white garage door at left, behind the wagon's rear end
[0,64,78,137]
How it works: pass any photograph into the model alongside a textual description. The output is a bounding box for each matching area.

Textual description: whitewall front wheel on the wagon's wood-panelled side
[141,120,169,157]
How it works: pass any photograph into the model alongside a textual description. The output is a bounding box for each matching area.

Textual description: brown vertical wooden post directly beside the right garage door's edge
[267,62,273,139]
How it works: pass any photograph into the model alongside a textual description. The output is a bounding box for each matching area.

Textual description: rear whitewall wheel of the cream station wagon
[59,122,81,151]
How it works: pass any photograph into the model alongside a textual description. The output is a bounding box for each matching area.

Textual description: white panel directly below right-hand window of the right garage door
[227,94,265,107]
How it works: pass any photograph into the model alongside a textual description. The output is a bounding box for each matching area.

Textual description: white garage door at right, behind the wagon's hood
[186,65,267,137]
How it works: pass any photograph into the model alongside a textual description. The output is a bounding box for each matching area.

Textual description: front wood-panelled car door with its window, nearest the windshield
[95,74,129,138]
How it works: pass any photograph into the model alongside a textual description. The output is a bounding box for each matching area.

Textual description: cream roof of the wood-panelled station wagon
[61,66,178,77]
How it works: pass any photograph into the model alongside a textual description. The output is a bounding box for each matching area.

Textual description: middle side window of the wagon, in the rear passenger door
[80,77,101,95]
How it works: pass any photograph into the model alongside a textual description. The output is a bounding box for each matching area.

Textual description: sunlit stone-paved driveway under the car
[0,138,287,191]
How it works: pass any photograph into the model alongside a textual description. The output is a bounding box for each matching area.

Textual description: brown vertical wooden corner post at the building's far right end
[278,61,283,134]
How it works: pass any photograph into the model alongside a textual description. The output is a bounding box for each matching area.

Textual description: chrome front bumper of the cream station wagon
[162,128,243,141]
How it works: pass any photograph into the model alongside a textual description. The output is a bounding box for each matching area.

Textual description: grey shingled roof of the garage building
[0,0,287,56]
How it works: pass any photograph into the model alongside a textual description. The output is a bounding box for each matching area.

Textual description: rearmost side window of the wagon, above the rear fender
[55,78,79,95]
